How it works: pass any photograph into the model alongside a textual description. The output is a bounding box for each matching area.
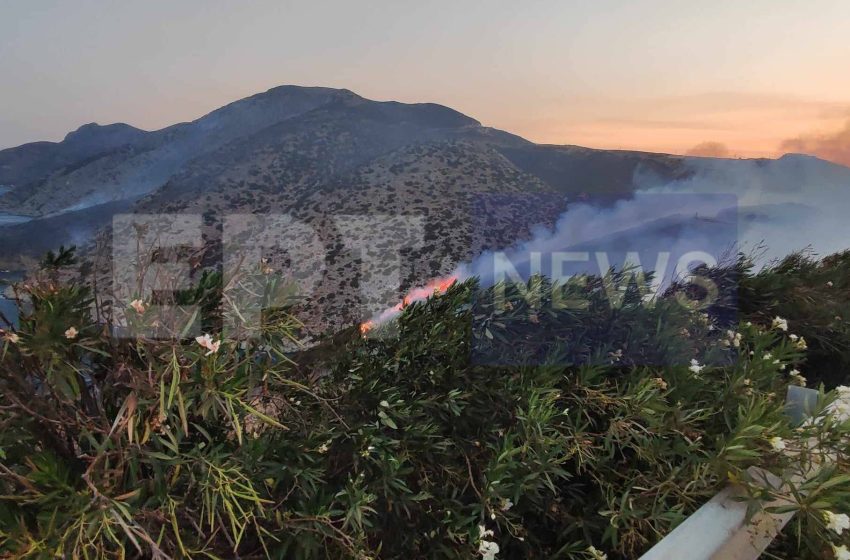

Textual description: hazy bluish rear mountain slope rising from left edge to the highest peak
[0,87,350,216]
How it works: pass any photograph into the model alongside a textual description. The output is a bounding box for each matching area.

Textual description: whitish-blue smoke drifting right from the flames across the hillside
[455,155,850,289]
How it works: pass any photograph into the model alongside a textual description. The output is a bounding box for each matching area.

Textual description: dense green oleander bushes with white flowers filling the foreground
[0,255,850,560]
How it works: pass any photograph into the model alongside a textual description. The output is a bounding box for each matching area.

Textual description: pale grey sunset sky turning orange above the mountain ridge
[0,0,850,165]
